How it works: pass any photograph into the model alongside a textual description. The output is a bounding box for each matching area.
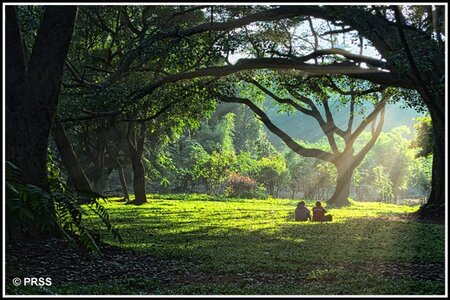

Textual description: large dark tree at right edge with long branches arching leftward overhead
[118,6,445,218]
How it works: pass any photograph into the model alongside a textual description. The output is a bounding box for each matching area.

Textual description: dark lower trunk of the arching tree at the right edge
[417,109,447,222]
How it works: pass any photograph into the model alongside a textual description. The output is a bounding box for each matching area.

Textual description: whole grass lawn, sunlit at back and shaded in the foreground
[7,195,445,295]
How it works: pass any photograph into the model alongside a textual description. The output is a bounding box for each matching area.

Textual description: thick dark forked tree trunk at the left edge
[5,5,77,188]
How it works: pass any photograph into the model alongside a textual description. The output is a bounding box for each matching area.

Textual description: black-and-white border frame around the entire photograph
[2,2,449,298]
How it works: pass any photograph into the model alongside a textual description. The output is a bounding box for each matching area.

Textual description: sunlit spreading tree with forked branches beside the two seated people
[219,72,390,206]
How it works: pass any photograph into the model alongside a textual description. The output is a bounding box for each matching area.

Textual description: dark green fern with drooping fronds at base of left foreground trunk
[6,153,122,253]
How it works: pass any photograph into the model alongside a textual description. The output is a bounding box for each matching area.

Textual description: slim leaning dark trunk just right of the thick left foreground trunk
[53,123,92,192]
